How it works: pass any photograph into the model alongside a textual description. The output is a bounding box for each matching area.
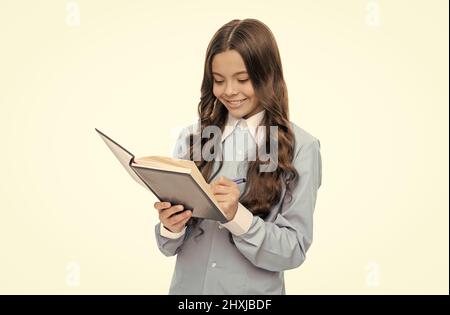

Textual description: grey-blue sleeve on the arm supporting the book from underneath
[155,128,189,256]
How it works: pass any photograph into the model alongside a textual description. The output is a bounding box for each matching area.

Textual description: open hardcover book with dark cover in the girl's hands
[95,128,228,223]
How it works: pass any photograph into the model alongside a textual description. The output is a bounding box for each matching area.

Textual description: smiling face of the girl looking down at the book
[212,50,262,118]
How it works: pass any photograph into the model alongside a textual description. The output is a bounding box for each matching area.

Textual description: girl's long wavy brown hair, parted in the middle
[183,19,298,242]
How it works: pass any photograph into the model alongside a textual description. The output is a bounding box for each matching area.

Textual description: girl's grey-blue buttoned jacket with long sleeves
[155,123,322,295]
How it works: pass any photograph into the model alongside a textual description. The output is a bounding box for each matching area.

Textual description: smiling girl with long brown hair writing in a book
[154,19,322,294]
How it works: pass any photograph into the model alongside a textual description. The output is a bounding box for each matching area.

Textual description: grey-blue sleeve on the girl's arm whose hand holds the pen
[233,139,322,271]
